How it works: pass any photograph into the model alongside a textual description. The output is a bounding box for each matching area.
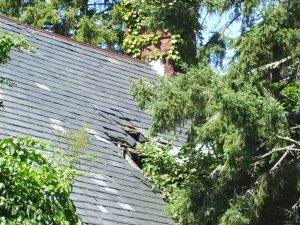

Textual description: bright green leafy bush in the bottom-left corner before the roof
[0,138,79,225]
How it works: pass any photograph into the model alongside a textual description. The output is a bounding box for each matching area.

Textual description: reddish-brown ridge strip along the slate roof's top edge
[0,14,150,66]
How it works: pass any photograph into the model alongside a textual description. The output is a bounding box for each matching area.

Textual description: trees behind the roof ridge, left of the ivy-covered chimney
[0,0,122,49]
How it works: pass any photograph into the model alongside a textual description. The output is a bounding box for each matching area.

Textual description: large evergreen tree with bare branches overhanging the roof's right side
[133,1,300,225]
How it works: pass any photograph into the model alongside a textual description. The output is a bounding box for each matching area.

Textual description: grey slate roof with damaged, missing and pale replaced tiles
[0,17,173,225]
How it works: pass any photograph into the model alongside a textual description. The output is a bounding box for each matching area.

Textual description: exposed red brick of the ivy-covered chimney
[141,32,175,77]
